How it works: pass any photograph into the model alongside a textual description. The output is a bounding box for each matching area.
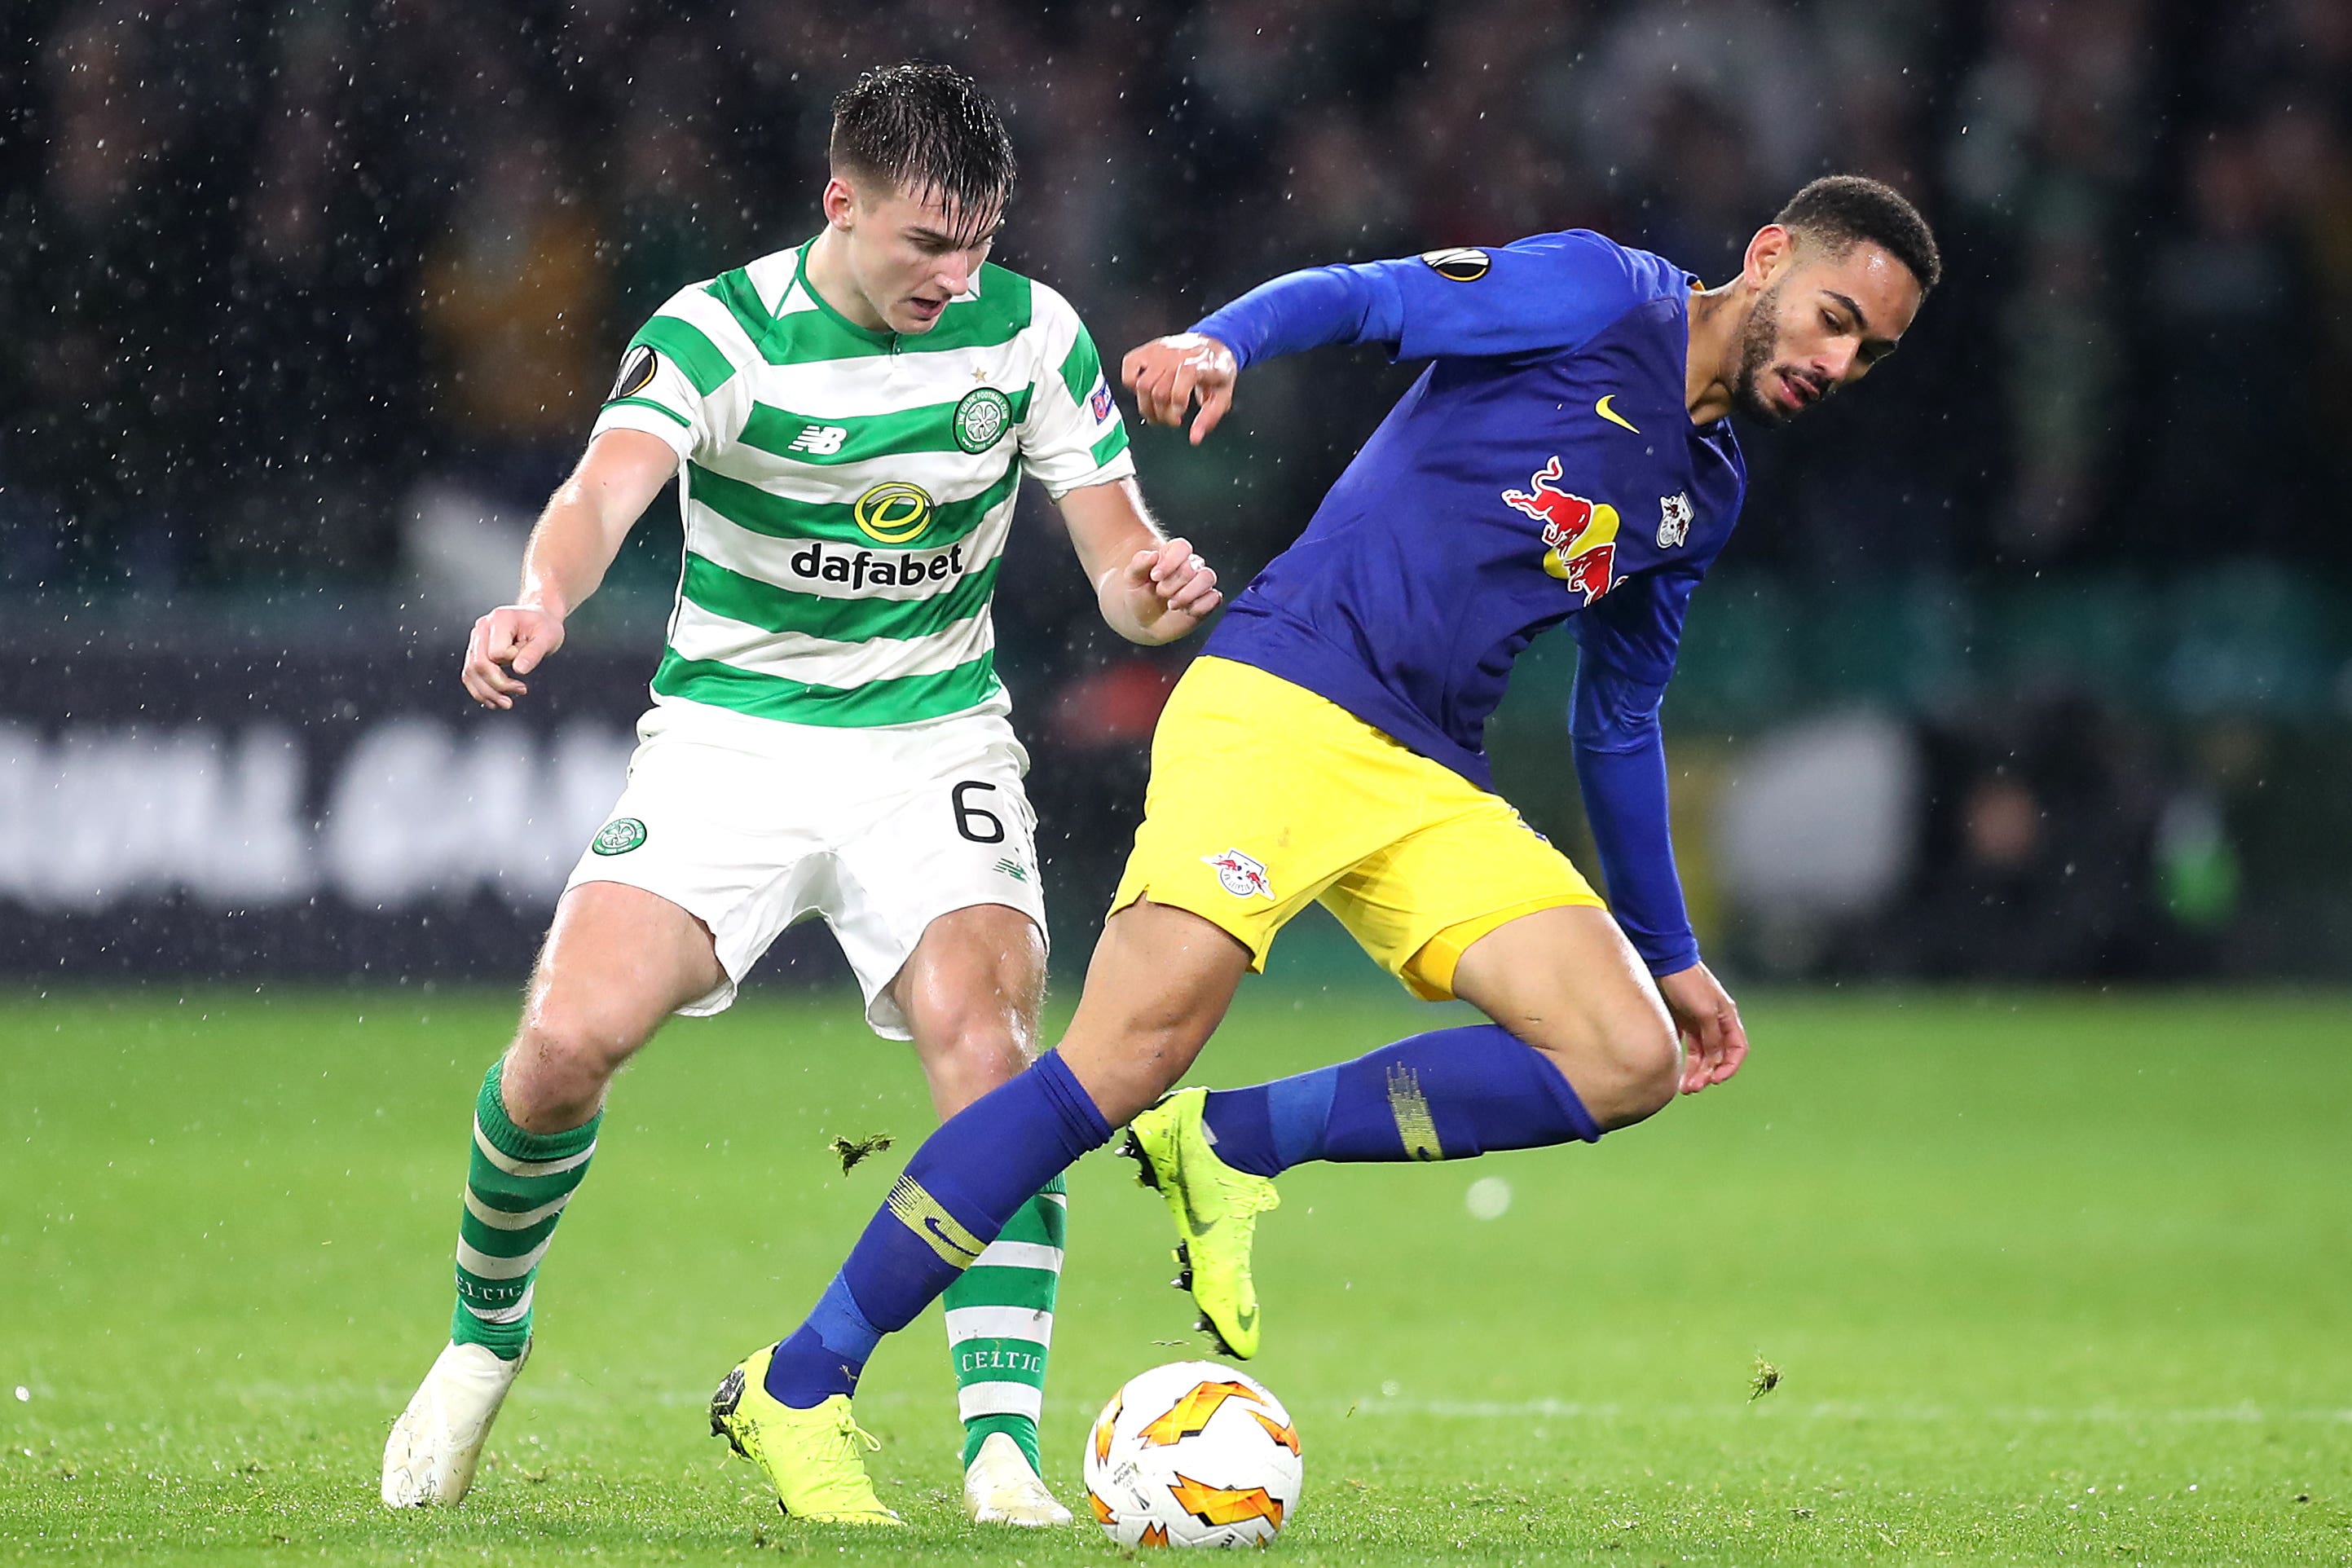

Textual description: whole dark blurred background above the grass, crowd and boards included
[0,0,2352,978]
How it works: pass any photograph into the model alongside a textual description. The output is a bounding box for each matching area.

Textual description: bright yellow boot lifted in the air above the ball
[1120,1089,1282,1361]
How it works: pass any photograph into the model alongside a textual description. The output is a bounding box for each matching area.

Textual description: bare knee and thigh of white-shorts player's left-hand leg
[520,882,725,1069]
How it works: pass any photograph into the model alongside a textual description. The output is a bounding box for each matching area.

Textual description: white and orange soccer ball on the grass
[1086,1361,1306,1547]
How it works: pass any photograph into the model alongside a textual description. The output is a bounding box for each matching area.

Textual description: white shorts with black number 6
[565,703,1046,1039]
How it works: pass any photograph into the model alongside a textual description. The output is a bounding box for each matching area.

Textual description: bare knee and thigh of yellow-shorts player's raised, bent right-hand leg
[1454,905,1680,1129]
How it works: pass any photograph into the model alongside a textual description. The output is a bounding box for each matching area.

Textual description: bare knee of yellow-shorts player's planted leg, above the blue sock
[1056,898,1251,1126]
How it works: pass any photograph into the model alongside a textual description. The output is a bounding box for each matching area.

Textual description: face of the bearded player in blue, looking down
[1731,244,1919,425]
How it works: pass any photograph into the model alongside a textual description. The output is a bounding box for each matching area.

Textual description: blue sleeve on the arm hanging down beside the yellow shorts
[1569,571,1701,976]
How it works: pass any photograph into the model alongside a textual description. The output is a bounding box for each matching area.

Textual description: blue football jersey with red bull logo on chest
[1195,231,1747,787]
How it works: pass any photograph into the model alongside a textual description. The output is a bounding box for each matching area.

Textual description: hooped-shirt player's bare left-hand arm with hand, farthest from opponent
[464,430,677,707]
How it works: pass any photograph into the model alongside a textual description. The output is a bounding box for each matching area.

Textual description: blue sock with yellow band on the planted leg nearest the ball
[767,1050,1110,1411]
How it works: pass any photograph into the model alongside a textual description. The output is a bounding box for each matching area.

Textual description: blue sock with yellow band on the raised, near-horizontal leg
[1202,1023,1601,1175]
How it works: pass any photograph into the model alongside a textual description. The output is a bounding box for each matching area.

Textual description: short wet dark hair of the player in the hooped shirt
[828,61,1016,240]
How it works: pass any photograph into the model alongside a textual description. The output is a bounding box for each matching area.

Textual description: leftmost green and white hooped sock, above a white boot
[449,1060,605,1361]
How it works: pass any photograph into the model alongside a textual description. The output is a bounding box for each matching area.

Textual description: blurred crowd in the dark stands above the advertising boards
[0,0,2352,592]
